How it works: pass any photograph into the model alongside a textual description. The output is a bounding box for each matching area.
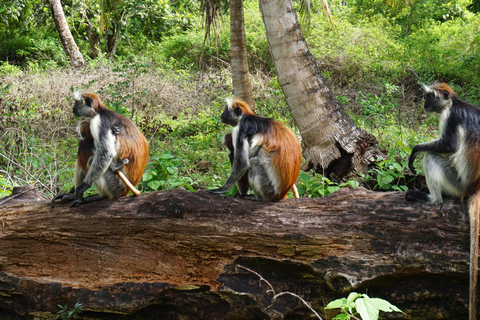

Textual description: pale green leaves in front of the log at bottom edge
[325,292,402,320]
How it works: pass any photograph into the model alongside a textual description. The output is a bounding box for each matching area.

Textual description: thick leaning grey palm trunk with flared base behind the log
[260,0,384,181]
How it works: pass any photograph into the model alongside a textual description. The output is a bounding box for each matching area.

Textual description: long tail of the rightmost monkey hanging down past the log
[468,193,480,320]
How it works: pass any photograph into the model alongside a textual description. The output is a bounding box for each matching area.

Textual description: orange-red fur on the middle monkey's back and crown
[232,98,302,201]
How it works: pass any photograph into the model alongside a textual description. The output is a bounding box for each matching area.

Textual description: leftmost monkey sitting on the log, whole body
[52,93,148,206]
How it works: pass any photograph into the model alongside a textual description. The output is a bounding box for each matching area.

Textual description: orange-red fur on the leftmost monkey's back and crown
[79,93,148,196]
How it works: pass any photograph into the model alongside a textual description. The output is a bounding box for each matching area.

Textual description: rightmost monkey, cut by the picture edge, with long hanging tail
[406,83,480,320]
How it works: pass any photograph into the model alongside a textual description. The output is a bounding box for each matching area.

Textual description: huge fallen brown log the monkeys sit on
[0,189,469,320]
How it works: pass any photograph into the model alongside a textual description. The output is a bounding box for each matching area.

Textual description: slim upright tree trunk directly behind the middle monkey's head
[230,0,255,108]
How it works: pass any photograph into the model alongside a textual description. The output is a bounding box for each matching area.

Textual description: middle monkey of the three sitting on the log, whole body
[209,98,302,201]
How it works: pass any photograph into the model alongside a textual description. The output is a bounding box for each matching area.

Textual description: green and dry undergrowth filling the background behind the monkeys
[0,0,480,197]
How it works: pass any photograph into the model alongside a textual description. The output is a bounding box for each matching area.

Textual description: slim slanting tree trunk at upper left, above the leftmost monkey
[50,0,86,68]
